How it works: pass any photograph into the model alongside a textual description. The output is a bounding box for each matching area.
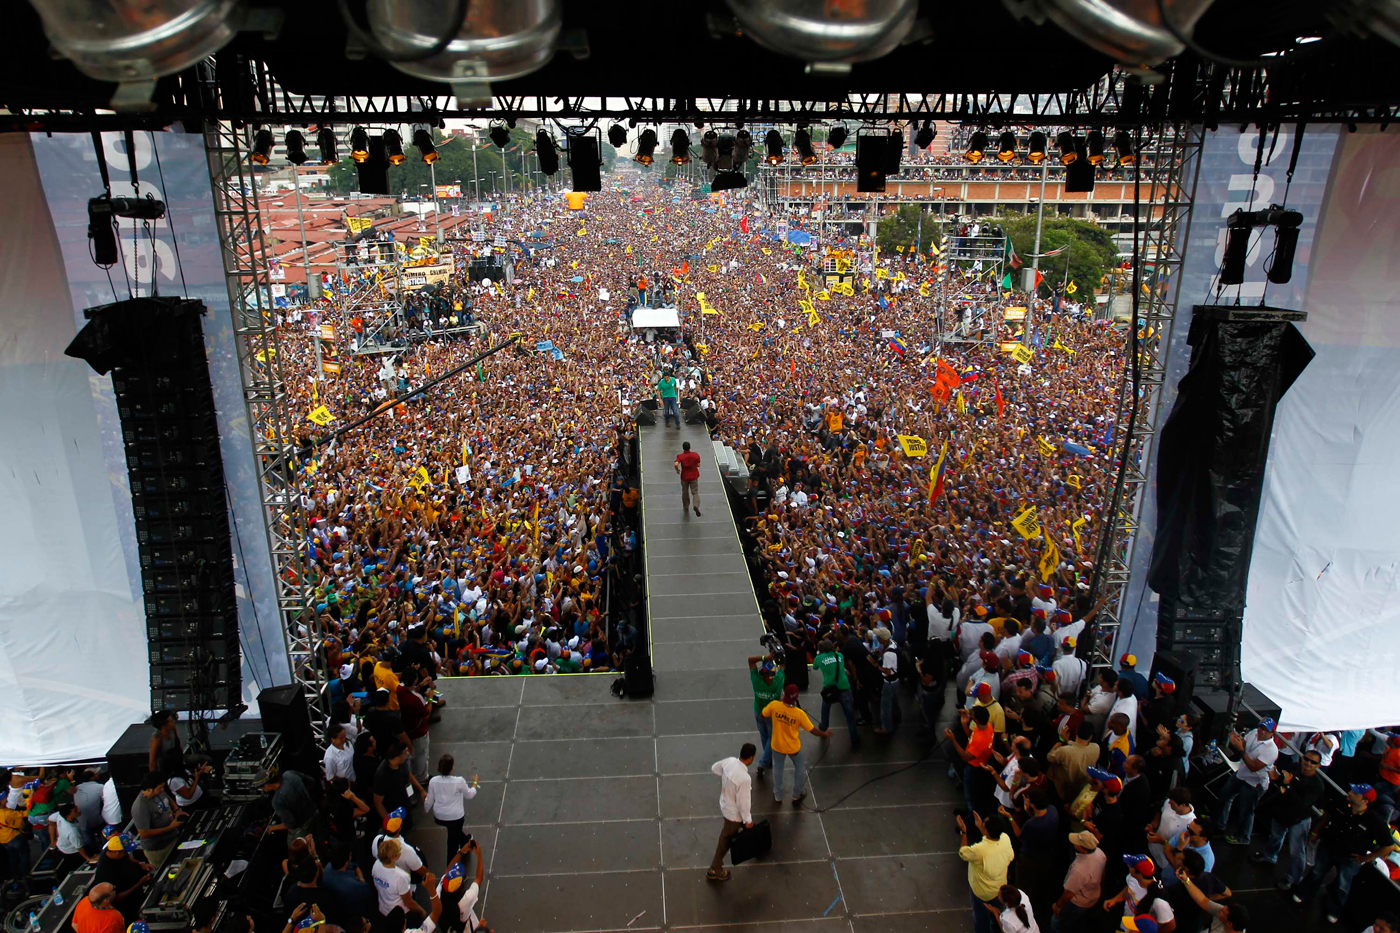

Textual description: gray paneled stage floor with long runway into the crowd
[410,426,972,933]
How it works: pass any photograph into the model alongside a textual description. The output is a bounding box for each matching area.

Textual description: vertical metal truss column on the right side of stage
[1095,123,1204,667]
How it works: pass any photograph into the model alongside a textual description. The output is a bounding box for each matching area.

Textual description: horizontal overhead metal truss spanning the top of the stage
[10,56,1400,132]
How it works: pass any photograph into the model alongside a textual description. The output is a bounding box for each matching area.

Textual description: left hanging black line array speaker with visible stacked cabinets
[66,298,242,711]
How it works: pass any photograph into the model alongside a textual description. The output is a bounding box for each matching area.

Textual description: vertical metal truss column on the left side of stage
[204,114,329,731]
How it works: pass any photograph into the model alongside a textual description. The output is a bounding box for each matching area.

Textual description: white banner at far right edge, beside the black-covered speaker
[1240,127,1400,730]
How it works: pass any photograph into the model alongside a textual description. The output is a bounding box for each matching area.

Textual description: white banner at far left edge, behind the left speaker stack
[0,133,151,765]
